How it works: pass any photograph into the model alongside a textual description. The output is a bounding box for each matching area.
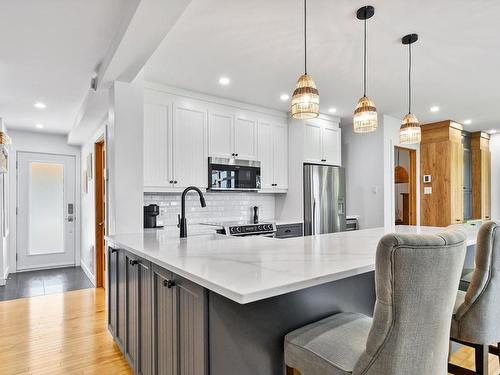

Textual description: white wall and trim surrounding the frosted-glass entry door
[9,130,81,272]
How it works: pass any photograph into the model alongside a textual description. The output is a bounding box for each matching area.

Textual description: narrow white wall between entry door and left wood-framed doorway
[80,124,105,285]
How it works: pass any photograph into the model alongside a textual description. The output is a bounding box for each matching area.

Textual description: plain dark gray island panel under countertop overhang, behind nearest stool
[208,272,375,375]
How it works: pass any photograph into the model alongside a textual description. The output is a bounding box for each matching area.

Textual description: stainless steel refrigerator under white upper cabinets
[304,164,346,236]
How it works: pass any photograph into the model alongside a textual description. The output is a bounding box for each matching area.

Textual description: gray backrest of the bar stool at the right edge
[454,221,500,344]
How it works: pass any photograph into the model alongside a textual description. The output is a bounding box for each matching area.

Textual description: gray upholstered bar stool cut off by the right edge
[448,221,500,374]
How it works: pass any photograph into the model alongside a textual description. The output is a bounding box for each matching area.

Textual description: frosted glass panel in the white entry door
[28,163,64,255]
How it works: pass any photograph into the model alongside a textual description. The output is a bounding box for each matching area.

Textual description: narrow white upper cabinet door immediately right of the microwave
[258,121,274,189]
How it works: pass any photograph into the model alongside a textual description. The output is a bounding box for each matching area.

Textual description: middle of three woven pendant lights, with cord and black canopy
[353,5,378,133]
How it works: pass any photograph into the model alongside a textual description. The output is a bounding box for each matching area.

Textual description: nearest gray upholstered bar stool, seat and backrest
[285,230,466,375]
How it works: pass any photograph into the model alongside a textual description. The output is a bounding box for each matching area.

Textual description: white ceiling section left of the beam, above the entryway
[0,0,135,133]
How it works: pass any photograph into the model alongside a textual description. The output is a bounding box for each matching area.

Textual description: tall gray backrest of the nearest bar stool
[353,229,466,375]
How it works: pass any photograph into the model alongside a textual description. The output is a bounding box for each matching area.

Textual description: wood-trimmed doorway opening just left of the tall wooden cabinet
[394,146,417,225]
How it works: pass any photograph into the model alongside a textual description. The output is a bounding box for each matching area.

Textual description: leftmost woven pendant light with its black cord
[291,0,319,119]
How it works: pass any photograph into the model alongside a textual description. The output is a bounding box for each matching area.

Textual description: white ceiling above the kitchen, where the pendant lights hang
[145,0,500,130]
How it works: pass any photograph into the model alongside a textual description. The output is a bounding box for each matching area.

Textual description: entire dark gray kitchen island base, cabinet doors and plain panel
[107,248,375,375]
